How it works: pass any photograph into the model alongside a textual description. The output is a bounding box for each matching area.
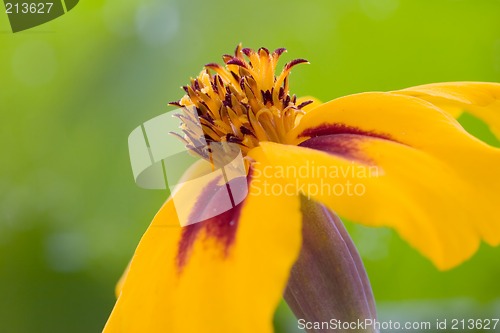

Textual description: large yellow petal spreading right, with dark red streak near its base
[251,93,500,269]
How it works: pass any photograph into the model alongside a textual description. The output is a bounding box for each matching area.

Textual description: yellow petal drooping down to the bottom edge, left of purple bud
[104,160,301,333]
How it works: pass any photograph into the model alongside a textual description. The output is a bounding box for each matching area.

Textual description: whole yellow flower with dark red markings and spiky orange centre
[104,47,500,333]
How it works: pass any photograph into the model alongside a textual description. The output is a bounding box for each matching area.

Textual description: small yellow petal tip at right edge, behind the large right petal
[393,82,500,139]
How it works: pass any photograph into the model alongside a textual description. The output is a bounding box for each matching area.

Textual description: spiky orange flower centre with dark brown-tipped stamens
[170,44,312,155]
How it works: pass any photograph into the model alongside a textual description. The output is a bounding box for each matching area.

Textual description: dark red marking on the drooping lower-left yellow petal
[176,172,251,272]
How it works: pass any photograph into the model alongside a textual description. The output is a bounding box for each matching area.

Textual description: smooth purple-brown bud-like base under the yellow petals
[285,197,377,332]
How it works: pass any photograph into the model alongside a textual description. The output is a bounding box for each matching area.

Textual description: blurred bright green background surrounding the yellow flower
[0,0,500,333]
